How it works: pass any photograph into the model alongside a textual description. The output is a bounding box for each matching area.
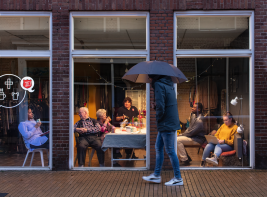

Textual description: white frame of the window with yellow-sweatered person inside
[173,11,255,170]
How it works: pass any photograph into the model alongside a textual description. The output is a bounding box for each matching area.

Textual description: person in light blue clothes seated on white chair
[18,109,49,150]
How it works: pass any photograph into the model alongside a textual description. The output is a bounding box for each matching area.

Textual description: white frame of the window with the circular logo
[0,11,53,170]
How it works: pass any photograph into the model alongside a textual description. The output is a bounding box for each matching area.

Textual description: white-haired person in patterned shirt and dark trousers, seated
[74,107,104,167]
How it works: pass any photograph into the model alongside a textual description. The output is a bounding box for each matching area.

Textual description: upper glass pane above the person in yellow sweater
[177,17,249,49]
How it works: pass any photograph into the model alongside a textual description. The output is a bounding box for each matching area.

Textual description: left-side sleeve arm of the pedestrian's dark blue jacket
[154,83,165,121]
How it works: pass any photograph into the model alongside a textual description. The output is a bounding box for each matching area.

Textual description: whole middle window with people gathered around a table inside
[69,12,149,170]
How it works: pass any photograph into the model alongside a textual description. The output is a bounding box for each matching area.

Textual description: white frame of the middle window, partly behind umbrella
[69,12,150,170]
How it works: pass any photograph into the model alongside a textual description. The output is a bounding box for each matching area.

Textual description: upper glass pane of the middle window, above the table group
[74,17,146,49]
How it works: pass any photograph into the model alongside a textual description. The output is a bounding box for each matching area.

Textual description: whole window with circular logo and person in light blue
[0,12,52,170]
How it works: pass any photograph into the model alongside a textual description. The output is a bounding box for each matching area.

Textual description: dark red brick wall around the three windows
[0,0,267,170]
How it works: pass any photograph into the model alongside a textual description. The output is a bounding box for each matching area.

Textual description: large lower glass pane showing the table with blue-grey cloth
[74,58,146,167]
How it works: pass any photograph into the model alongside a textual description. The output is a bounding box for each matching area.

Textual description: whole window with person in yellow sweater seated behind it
[174,11,255,168]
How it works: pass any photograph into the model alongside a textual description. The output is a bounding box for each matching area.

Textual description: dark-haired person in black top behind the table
[116,97,139,159]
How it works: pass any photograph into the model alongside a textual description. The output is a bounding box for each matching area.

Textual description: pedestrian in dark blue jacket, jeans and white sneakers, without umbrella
[143,75,183,186]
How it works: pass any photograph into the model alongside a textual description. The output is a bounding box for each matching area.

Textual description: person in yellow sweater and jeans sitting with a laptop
[201,112,238,167]
